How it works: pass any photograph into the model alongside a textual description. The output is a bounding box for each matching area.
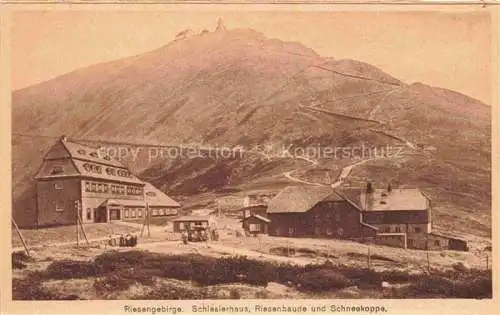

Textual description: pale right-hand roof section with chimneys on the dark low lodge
[360,188,429,211]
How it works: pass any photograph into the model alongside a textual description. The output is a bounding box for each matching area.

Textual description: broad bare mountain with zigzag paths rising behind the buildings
[12,28,491,239]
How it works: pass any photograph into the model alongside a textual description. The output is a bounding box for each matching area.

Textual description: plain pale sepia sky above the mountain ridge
[10,10,492,104]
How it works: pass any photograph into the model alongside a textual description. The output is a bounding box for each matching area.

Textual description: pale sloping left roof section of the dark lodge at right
[267,185,333,213]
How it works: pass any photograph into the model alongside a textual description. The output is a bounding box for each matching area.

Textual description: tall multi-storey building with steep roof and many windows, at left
[35,137,180,226]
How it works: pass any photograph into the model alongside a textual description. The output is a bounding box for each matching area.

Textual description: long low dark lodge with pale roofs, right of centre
[246,183,467,251]
